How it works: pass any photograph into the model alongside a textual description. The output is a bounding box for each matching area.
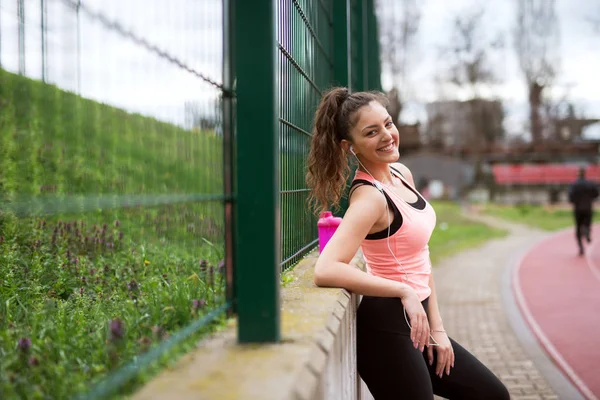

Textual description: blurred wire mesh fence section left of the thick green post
[0,0,234,399]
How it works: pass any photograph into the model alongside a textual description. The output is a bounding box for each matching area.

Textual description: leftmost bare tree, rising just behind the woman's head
[377,0,421,123]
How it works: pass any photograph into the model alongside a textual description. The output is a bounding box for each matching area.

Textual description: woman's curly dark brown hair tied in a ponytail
[306,87,388,213]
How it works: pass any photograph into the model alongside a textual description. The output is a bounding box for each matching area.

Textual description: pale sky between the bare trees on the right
[382,0,600,137]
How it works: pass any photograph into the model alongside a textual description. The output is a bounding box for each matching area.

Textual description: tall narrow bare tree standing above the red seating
[515,0,559,143]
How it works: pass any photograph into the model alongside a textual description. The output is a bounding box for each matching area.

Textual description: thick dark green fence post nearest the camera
[232,0,281,343]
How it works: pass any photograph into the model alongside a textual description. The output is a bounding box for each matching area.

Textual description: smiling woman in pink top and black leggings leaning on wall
[307,88,510,400]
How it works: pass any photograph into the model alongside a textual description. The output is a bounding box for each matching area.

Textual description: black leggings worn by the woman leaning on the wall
[357,296,510,400]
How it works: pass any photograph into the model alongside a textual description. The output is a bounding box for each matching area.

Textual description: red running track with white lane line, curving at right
[512,226,600,400]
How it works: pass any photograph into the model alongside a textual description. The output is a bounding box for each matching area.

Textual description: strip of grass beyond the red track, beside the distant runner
[482,204,599,231]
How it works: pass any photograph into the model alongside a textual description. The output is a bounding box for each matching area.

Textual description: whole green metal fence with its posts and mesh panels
[0,0,379,398]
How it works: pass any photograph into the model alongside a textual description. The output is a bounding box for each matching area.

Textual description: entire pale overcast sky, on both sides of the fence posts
[0,0,600,135]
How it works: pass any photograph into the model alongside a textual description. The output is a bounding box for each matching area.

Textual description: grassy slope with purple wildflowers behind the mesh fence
[0,70,225,399]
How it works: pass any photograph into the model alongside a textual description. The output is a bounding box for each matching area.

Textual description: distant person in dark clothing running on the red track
[569,168,598,256]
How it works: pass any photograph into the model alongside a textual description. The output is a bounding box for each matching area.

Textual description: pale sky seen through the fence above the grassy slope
[0,0,223,125]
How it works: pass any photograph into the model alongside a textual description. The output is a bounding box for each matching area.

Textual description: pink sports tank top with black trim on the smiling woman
[350,167,436,301]
